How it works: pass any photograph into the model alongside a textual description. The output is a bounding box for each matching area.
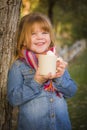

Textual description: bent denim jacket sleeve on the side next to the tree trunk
[7,65,41,106]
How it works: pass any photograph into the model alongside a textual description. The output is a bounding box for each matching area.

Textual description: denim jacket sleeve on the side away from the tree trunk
[53,70,77,98]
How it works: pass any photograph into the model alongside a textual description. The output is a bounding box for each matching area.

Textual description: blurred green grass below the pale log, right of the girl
[67,49,87,130]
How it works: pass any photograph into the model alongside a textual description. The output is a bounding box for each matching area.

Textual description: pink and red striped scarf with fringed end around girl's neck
[23,47,60,97]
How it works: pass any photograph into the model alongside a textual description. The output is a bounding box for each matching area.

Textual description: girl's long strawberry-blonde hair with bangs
[16,13,54,58]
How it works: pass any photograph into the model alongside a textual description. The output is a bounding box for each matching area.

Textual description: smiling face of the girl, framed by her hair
[30,25,51,54]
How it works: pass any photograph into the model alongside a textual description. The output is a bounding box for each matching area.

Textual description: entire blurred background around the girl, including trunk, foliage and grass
[0,0,87,130]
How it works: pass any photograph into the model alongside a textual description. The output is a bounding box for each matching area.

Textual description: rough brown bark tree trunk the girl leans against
[0,0,21,130]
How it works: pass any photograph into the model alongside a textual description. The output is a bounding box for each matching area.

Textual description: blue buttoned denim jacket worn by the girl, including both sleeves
[7,60,77,130]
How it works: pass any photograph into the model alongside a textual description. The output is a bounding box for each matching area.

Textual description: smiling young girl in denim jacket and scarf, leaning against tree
[7,13,77,130]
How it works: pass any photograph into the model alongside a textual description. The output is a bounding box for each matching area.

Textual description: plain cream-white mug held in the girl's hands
[38,54,57,75]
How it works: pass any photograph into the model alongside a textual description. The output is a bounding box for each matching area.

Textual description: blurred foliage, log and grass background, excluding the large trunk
[20,0,87,130]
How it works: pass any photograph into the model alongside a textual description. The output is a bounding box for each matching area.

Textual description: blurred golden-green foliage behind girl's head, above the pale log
[21,0,87,45]
